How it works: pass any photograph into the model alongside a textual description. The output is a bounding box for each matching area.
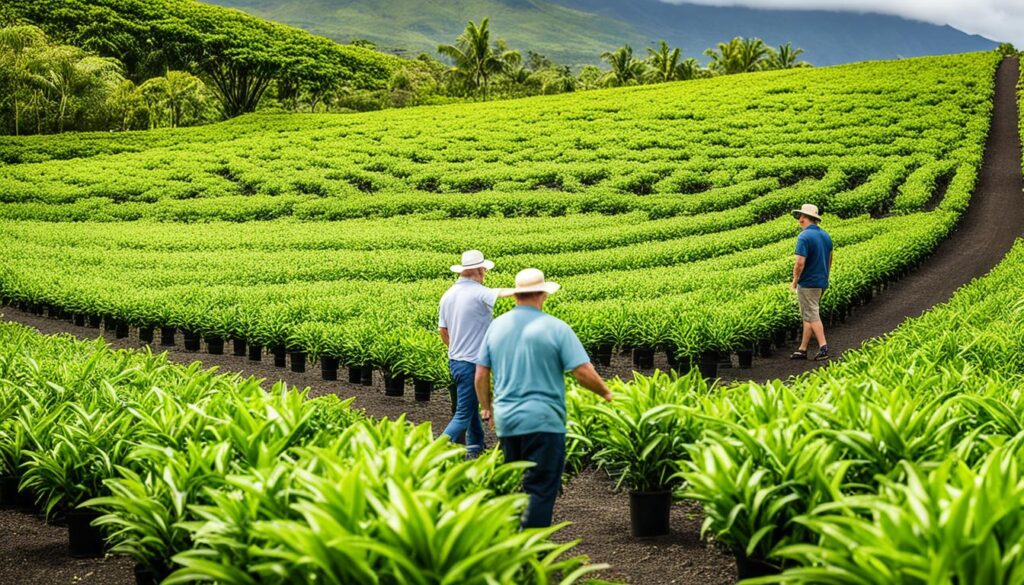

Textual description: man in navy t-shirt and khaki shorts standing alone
[790,204,833,361]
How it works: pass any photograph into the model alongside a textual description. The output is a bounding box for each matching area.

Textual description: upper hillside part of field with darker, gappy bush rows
[0,53,996,221]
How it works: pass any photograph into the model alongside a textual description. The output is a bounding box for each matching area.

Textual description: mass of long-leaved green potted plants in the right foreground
[568,238,1024,584]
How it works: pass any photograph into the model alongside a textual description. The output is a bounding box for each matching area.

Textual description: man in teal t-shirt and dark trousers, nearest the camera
[476,268,611,528]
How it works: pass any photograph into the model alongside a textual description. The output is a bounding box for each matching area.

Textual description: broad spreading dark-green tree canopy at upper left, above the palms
[0,0,400,118]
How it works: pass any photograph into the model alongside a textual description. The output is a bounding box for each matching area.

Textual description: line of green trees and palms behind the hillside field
[0,0,806,134]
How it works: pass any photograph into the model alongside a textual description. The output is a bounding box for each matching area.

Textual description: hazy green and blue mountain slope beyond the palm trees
[208,0,995,66]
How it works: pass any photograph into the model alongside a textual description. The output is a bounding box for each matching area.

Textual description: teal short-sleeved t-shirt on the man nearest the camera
[476,306,590,436]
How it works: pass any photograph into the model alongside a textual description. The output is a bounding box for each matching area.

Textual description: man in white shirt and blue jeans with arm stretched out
[437,250,512,457]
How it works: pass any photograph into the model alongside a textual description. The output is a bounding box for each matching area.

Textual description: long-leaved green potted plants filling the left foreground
[0,324,600,585]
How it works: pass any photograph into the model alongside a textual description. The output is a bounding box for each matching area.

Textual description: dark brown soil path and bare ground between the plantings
[0,59,1024,585]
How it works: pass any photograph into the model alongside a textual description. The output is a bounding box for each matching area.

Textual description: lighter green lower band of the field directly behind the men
[0,198,973,383]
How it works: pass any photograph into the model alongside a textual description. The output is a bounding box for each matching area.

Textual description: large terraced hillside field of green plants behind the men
[0,53,997,384]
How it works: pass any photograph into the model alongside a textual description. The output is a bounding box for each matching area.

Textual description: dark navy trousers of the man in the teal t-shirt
[502,432,565,530]
